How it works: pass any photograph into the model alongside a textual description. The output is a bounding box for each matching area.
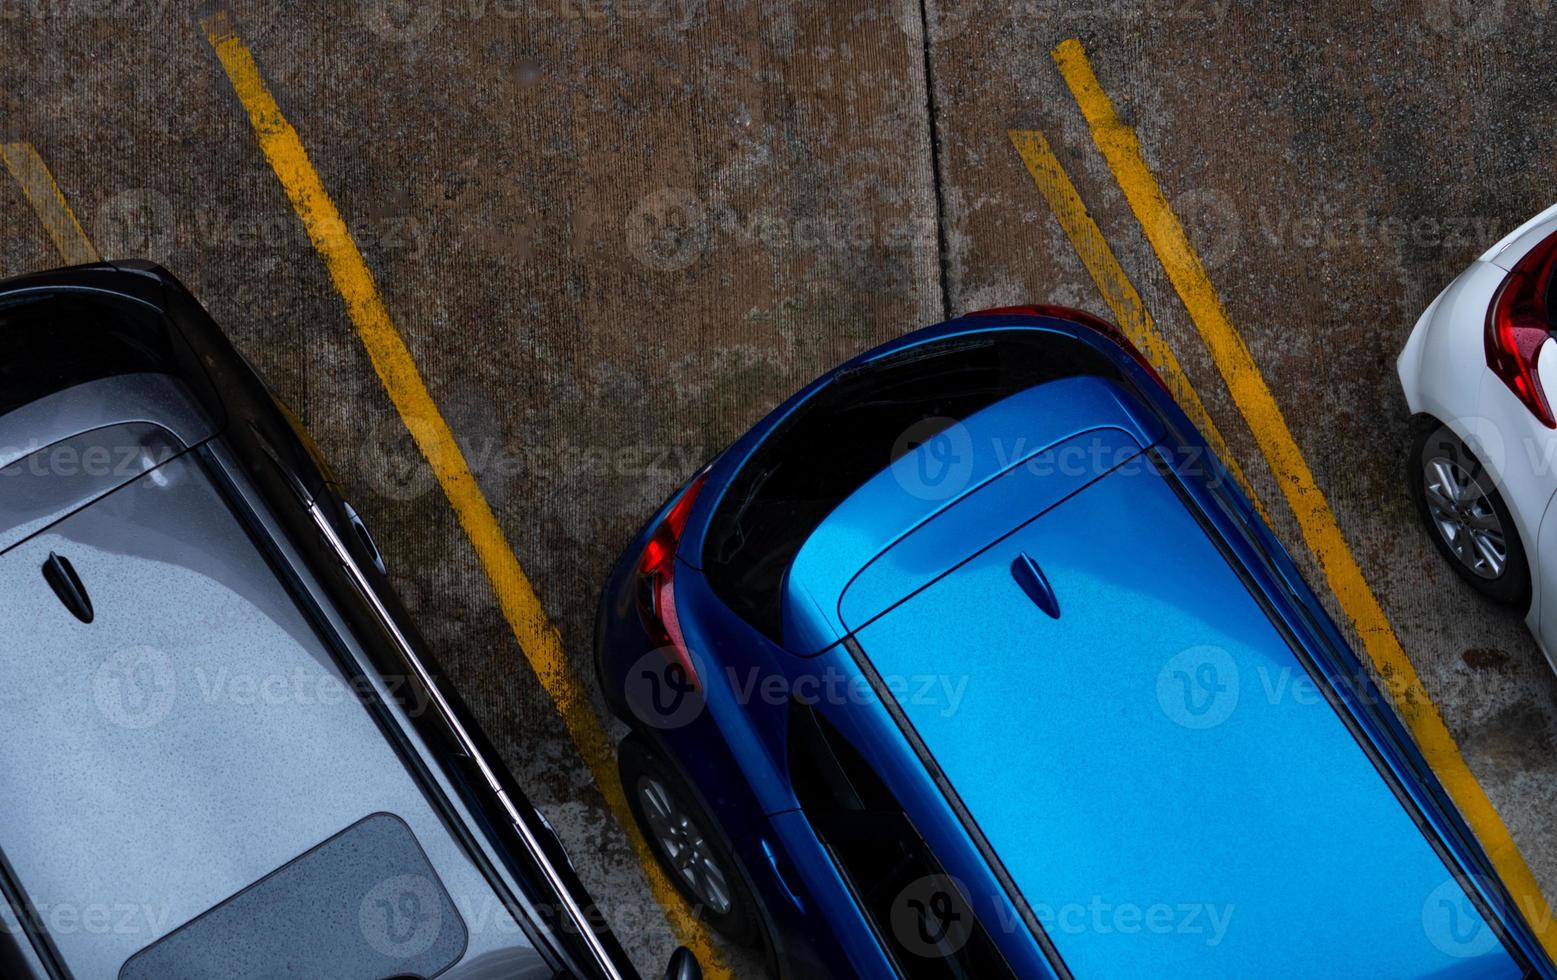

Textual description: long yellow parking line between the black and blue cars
[202,11,730,977]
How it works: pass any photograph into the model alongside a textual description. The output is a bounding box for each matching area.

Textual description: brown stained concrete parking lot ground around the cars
[0,0,1557,972]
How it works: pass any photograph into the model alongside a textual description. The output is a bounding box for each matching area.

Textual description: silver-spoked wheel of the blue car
[617,734,760,946]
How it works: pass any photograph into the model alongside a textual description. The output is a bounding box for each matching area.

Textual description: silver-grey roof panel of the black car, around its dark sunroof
[0,442,548,977]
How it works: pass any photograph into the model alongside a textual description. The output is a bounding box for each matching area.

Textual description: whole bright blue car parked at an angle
[596,307,1554,980]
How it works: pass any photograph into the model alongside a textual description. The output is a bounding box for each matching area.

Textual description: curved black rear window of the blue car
[702,330,1121,640]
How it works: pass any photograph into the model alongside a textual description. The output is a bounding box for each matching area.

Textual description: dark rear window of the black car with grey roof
[0,291,173,414]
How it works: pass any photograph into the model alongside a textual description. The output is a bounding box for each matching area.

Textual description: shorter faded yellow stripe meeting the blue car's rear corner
[1006,129,1271,522]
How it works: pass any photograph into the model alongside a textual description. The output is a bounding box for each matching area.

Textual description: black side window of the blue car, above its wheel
[789,704,1015,980]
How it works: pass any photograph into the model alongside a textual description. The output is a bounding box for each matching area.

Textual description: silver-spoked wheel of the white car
[1411,425,1531,605]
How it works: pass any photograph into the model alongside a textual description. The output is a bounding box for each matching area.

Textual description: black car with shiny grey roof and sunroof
[0,263,698,980]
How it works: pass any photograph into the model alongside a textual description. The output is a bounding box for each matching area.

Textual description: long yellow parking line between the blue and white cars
[1054,39,1557,957]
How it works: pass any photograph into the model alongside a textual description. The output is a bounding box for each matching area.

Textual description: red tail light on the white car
[1487,235,1557,428]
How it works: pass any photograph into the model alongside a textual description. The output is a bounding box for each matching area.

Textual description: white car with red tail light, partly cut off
[1397,206,1557,668]
